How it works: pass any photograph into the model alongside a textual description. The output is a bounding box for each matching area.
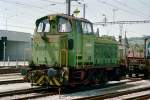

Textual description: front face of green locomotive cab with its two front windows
[32,16,73,67]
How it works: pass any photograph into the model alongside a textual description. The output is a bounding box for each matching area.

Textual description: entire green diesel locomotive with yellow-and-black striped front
[26,14,125,86]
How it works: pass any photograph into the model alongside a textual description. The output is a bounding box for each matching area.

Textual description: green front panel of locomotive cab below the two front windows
[32,34,67,67]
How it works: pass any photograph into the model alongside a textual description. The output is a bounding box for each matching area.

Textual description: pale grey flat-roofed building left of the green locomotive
[0,30,31,61]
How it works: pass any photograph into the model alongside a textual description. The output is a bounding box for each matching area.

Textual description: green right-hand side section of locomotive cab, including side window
[81,21,95,67]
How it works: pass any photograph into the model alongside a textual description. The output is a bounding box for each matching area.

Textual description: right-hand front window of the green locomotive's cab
[58,17,72,32]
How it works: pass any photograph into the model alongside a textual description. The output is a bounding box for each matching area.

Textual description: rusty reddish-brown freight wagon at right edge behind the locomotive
[127,37,150,78]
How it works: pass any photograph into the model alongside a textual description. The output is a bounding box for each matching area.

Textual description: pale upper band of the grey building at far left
[0,30,31,42]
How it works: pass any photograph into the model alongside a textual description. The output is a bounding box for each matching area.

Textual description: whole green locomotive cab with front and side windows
[32,15,95,67]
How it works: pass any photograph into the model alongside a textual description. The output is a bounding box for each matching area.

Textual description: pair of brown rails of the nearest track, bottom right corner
[74,87,150,100]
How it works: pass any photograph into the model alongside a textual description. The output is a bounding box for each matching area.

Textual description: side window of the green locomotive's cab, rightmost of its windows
[81,22,93,34]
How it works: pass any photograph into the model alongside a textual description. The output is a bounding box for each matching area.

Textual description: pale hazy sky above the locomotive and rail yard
[0,0,150,37]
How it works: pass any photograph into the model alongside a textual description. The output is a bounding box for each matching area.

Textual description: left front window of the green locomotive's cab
[37,19,50,32]
